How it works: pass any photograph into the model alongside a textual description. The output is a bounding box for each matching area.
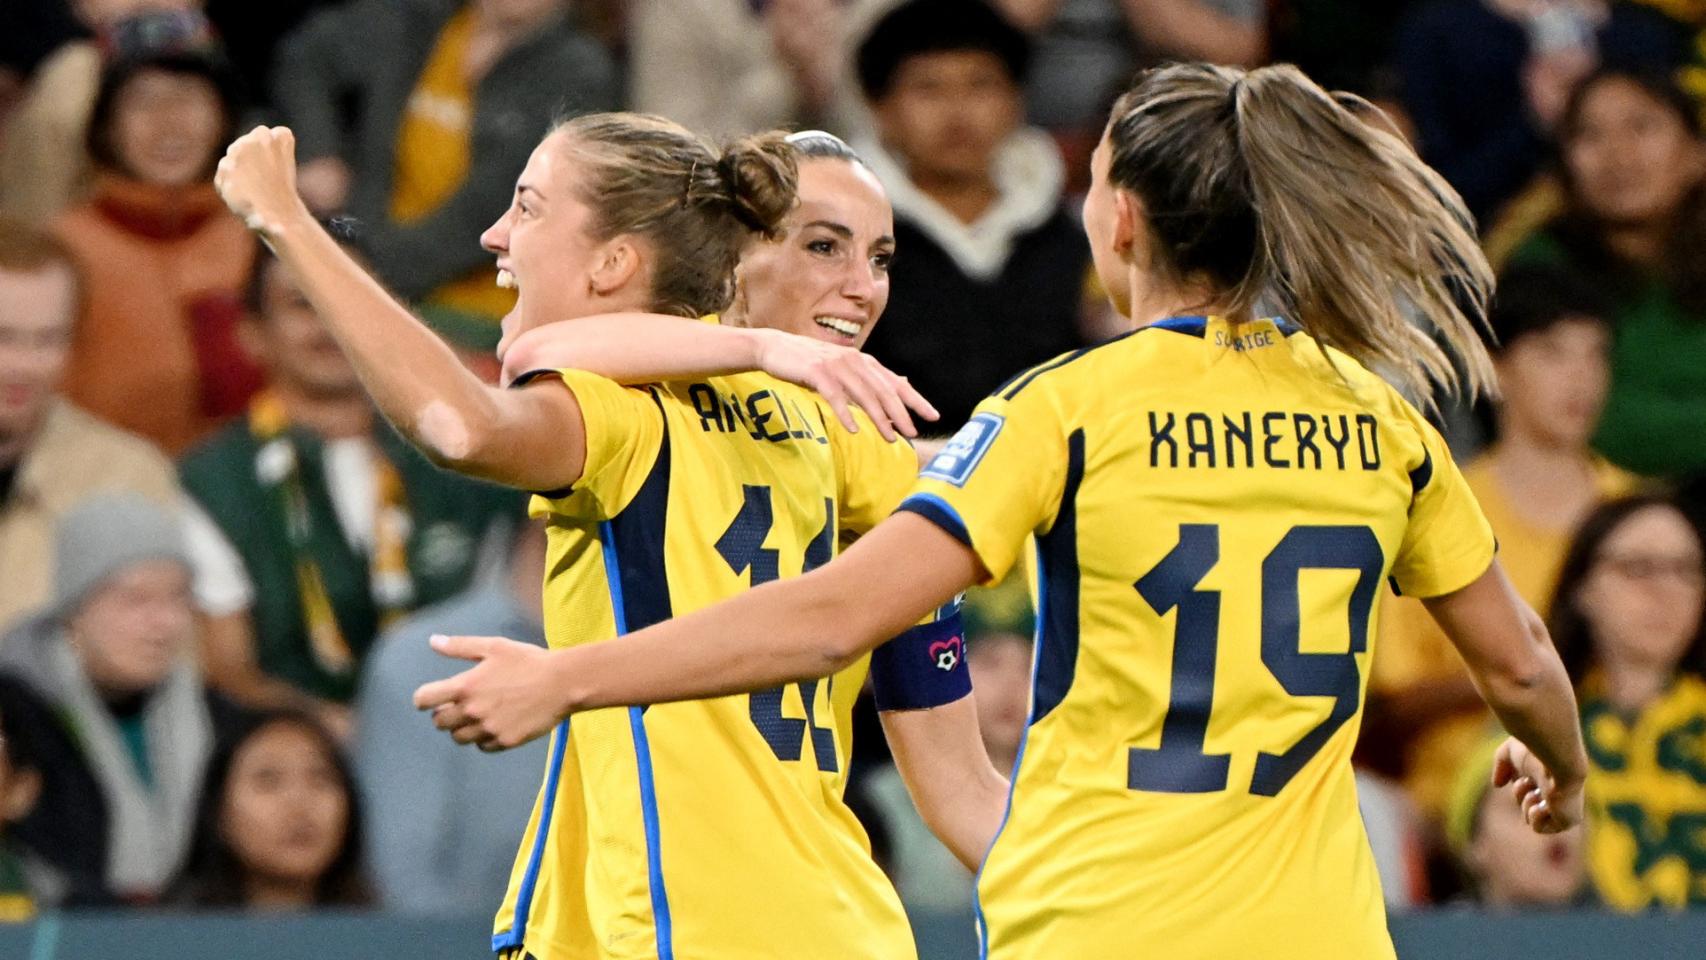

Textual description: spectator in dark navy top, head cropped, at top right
[1396,0,1687,222]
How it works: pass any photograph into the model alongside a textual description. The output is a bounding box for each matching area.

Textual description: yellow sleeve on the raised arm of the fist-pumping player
[531,370,664,520]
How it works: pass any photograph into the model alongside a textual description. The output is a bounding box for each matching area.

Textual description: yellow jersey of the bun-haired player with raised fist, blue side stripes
[493,372,918,960]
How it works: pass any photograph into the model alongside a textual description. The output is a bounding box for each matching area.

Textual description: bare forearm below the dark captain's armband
[879,694,1007,871]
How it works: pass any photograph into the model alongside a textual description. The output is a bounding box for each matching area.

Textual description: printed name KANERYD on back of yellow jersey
[1148,411,1380,472]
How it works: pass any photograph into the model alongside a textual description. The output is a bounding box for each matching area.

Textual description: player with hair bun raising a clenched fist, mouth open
[218,114,1003,960]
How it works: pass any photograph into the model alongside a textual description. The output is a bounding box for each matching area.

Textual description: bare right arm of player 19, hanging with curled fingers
[1425,561,1588,834]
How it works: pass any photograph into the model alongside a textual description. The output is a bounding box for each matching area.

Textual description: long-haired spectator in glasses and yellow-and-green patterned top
[1551,494,1706,912]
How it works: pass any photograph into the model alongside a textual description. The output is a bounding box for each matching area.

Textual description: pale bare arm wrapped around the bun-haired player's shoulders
[503,314,937,440]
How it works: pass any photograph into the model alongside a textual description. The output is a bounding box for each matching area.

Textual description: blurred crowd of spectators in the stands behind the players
[0,0,1706,919]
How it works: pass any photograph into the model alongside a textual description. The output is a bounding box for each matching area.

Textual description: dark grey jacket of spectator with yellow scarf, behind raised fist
[273,0,619,297]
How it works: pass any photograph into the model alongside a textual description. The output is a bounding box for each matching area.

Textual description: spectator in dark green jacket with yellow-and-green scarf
[179,239,519,732]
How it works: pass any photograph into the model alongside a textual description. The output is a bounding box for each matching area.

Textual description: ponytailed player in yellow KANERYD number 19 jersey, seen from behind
[416,65,1587,960]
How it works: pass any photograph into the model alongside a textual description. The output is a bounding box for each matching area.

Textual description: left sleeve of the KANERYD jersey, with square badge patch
[901,385,1068,583]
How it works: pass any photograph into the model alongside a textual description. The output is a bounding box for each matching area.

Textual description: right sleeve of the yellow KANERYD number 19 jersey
[1392,411,1496,597]
